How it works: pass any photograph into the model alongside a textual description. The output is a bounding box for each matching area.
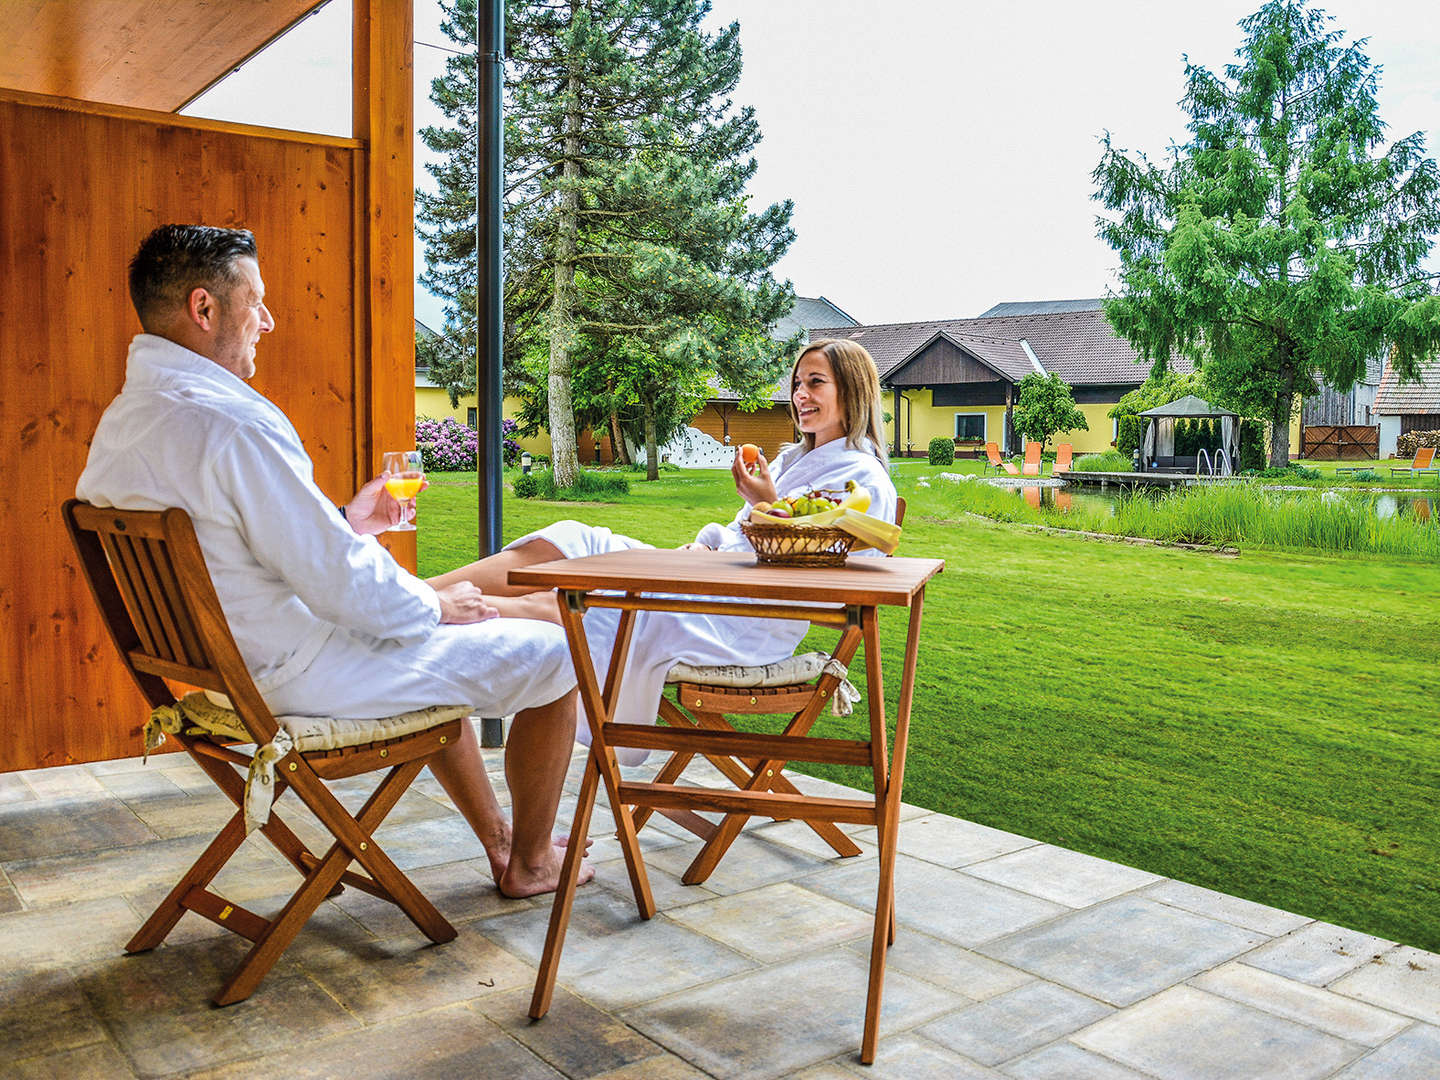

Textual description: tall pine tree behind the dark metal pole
[420,0,793,487]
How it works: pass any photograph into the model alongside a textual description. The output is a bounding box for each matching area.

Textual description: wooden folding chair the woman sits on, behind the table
[634,498,906,886]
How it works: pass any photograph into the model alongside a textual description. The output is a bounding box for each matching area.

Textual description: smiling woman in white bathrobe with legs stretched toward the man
[432,340,896,743]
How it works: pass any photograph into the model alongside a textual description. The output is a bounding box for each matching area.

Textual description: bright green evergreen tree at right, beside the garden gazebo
[1094,0,1440,465]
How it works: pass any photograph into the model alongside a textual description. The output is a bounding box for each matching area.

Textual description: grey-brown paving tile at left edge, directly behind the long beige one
[0,791,154,864]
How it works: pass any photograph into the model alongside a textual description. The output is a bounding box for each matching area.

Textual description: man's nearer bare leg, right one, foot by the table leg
[495,691,595,897]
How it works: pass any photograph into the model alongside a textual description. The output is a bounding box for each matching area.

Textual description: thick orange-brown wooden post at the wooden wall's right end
[351,0,423,570]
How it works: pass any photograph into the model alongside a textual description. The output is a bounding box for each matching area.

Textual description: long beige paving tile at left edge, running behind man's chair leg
[4,837,279,914]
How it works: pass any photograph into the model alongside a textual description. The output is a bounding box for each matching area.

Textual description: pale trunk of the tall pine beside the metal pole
[549,37,580,488]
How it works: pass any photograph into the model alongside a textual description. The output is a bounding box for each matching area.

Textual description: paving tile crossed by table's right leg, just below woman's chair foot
[802,855,1067,948]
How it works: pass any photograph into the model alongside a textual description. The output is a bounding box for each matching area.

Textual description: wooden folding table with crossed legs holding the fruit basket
[510,549,945,1064]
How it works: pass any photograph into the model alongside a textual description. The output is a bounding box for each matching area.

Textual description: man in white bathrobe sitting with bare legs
[76,226,589,896]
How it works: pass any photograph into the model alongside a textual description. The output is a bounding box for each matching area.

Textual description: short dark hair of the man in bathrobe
[130,225,256,330]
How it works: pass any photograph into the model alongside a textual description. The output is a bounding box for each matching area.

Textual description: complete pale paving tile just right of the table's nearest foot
[920,982,1113,1066]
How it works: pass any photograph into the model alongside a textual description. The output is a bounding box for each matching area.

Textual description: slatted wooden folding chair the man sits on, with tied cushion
[65,500,469,1005]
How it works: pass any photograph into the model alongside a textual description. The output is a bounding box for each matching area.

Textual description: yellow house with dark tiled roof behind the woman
[812,300,1188,455]
